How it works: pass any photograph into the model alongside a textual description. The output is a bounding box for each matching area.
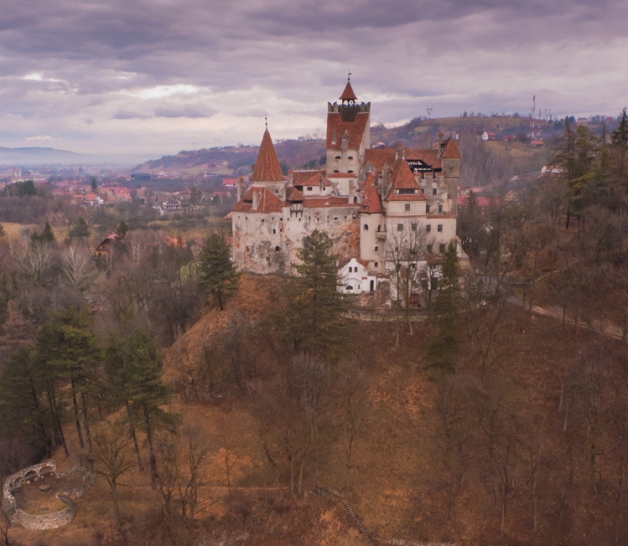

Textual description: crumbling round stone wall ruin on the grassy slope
[2,460,96,530]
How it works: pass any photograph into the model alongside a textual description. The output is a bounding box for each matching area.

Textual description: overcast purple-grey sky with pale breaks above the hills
[0,0,628,154]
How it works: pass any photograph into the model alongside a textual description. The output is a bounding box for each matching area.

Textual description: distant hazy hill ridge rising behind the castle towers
[133,116,562,186]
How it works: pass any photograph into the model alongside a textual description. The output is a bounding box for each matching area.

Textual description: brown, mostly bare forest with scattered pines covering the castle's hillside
[0,111,628,546]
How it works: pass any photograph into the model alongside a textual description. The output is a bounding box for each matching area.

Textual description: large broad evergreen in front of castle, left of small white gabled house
[286,230,348,356]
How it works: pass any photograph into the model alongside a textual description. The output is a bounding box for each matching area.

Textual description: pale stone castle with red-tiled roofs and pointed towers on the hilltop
[231,81,460,300]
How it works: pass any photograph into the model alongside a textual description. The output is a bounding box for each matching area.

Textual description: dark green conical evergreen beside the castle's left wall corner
[199,233,240,311]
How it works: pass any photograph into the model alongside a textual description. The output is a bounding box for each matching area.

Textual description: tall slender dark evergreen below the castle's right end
[426,241,460,374]
